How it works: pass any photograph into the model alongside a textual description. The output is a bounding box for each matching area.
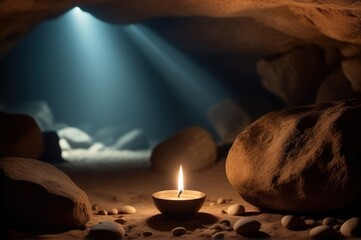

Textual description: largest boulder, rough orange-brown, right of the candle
[226,99,361,212]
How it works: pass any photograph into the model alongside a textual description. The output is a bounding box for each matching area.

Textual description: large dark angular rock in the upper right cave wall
[257,47,325,106]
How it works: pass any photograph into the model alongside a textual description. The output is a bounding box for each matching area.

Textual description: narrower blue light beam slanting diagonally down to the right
[126,25,229,122]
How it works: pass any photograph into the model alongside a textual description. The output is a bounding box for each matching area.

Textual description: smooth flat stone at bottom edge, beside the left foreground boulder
[89,221,125,239]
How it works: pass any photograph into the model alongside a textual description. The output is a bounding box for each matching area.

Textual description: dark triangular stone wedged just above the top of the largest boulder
[316,69,357,103]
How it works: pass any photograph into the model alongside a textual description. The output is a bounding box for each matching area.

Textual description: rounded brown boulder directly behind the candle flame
[150,126,217,172]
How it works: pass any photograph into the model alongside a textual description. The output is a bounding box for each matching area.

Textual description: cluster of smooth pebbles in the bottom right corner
[281,215,361,238]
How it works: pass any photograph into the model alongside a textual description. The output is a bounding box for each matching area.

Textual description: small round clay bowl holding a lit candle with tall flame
[152,166,206,218]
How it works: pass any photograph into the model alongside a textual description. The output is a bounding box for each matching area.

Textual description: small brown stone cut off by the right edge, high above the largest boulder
[341,58,361,93]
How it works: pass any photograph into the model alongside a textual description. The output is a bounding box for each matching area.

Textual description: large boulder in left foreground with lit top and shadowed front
[0,158,92,230]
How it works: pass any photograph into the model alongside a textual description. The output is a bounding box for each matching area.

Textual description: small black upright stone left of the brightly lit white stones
[39,131,65,163]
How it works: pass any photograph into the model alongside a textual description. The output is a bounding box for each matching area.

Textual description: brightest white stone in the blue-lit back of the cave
[58,127,92,148]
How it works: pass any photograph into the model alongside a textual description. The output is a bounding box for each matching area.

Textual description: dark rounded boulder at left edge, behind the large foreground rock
[0,111,43,158]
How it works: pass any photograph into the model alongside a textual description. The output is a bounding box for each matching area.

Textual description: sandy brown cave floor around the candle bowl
[8,160,346,239]
